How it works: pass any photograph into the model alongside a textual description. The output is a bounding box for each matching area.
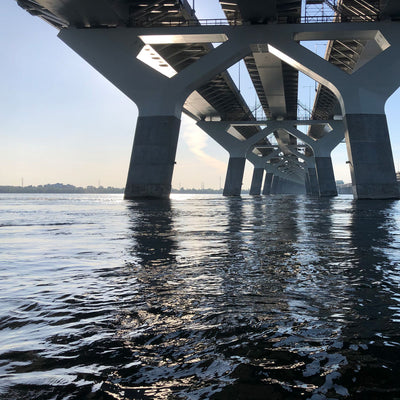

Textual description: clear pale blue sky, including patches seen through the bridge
[0,0,400,189]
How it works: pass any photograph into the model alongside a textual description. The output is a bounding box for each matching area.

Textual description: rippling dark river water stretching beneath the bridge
[0,195,400,400]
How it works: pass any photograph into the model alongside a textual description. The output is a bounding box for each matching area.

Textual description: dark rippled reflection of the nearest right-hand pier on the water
[349,201,399,338]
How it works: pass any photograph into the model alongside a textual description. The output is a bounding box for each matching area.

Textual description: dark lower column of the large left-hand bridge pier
[124,116,180,199]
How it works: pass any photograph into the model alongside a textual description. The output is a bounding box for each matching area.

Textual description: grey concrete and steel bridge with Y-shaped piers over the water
[17,0,400,199]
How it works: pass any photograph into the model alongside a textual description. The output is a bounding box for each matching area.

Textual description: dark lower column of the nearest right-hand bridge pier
[345,114,399,199]
